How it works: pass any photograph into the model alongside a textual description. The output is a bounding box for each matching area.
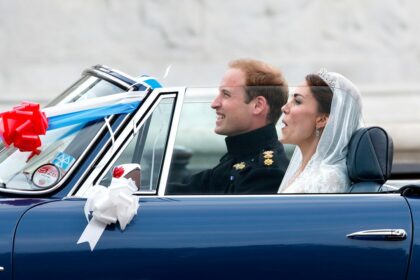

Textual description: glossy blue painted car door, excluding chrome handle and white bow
[13,194,413,279]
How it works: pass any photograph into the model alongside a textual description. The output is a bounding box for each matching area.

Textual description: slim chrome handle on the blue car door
[347,229,407,241]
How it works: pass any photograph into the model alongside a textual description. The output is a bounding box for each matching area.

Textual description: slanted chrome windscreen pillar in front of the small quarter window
[71,88,183,197]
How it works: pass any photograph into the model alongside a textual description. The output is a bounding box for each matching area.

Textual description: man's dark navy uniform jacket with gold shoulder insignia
[167,124,289,194]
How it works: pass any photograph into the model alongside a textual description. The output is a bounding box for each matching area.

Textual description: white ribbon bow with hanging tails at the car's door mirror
[77,177,139,251]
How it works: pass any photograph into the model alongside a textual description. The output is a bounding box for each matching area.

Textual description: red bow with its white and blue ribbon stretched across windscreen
[0,92,146,153]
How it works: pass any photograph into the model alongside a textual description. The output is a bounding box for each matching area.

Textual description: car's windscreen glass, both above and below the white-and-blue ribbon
[0,71,130,191]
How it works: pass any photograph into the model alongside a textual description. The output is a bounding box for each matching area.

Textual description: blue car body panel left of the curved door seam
[0,198,48,279]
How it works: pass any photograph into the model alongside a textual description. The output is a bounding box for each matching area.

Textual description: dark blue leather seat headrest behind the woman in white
[347,127,394,193]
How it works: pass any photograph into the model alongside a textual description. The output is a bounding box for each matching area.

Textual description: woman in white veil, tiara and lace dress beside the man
[278,70,362,193]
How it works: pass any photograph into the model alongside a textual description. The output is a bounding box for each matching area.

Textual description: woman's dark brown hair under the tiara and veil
[305,74,333,115]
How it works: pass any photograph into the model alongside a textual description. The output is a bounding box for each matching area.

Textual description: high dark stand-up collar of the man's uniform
[225,124,278,157]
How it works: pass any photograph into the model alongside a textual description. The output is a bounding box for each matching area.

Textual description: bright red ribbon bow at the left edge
[0,102,48,153]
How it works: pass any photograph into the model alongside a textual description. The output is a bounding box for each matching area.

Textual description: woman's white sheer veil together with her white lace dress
[278,70,363,193]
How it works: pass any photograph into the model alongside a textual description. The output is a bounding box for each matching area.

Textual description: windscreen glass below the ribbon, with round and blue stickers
[0,121,103,190]
